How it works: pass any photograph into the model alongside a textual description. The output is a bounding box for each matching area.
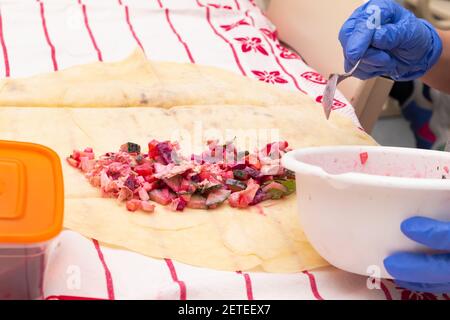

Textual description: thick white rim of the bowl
[281,145,450,191]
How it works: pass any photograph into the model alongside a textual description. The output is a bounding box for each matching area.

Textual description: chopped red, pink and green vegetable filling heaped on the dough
[67,140,295,213]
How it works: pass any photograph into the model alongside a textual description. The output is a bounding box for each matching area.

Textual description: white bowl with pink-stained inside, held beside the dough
[283,146,450,278]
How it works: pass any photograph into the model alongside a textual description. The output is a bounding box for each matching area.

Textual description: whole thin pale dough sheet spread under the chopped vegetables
[0,50,374,272]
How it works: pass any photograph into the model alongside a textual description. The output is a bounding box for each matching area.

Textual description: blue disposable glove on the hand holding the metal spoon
[339,0,442,81]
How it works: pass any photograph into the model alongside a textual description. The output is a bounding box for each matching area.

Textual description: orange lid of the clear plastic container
[0,141,64,245]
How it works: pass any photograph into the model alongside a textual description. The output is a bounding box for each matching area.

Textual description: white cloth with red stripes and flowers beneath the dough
[0,0,449,299]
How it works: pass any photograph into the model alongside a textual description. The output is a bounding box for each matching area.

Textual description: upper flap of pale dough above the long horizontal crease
[0,50,310,108]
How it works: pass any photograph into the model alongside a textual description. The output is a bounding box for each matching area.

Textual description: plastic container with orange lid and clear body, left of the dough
[0,141,64,299]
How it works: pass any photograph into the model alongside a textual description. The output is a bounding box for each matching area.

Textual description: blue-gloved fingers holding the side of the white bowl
[384,217,450,293]
